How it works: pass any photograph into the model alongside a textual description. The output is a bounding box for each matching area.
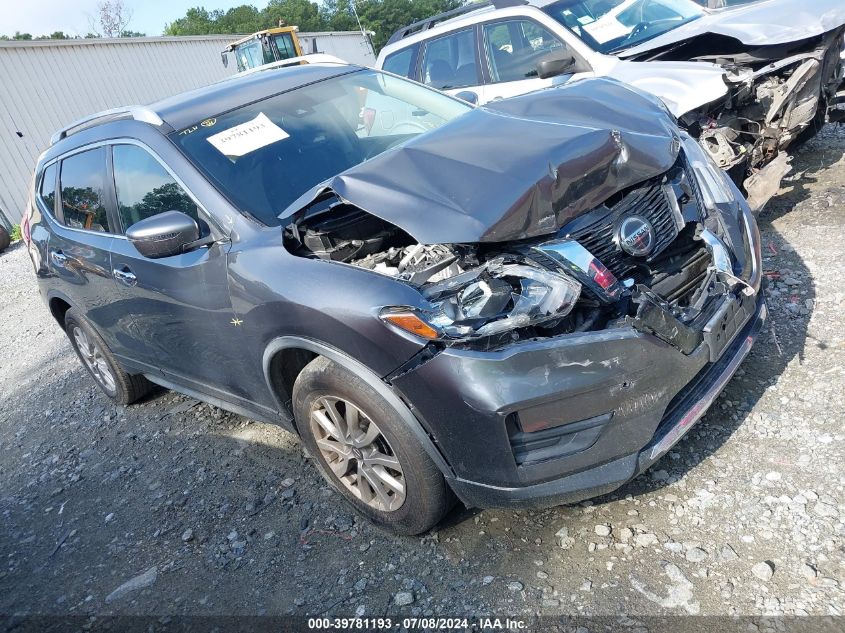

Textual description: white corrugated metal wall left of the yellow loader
[0,35,234,230]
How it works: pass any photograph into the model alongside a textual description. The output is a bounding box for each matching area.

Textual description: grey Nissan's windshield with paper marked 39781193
[171,70,472,225]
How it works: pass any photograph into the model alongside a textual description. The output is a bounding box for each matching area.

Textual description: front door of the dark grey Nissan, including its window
[111,142,238,395]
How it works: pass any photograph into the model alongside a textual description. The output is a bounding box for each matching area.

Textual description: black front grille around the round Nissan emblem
[563,158,684,279]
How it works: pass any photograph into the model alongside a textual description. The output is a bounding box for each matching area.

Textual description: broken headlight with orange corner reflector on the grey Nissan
[380,259,581,340]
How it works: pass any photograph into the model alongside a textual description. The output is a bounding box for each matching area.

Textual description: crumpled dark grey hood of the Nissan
[281,79,679,244]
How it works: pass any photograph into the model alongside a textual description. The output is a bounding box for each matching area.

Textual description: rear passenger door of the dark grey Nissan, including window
[42,146,124,350]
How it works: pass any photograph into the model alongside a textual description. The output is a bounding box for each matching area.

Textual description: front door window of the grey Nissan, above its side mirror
[112,145,202,230]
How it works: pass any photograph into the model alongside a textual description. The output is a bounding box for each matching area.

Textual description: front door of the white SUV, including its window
[479,18,574,103]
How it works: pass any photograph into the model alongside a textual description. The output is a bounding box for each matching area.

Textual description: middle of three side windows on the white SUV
[422,29,481,90]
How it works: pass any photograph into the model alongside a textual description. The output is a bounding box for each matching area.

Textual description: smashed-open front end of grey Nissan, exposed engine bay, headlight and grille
[283,137,755,353]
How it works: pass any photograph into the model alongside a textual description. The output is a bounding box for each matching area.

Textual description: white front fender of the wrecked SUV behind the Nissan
[605,60,728,117]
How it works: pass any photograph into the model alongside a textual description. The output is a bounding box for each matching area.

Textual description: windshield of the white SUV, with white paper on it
[543,0,704,53]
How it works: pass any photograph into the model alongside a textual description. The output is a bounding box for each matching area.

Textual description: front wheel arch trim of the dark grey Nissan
[263,336,455,479]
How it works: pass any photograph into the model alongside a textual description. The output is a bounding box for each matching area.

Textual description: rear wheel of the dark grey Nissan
[65,308,152,405]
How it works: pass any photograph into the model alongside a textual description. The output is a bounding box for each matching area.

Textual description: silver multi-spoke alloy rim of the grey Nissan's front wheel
[310,396,406,512]
